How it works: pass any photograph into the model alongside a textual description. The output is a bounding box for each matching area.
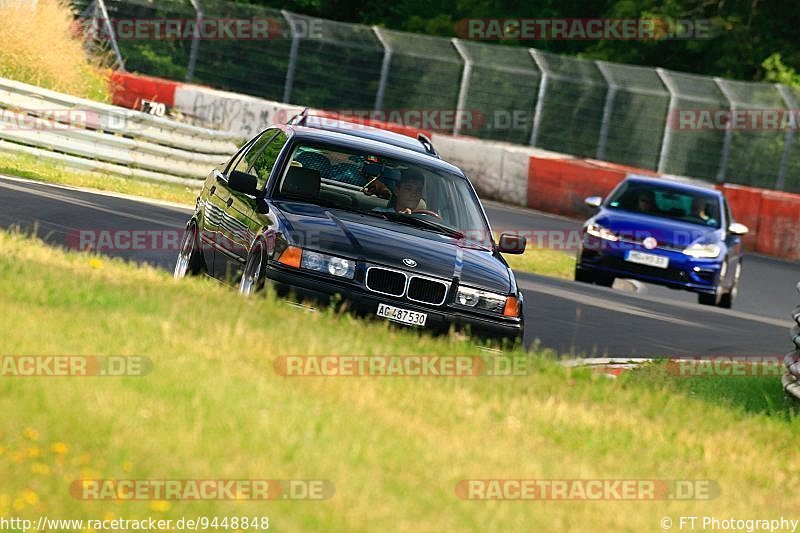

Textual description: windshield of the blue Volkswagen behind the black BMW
[606,181,720,228]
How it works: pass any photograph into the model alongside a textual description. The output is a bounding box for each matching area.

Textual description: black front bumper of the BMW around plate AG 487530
[266,263,524,341]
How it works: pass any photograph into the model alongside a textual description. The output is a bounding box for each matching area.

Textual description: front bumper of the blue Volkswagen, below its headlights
[577,235,723,294]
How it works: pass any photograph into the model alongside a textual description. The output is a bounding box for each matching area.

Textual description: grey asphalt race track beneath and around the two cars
[0,177,800,357]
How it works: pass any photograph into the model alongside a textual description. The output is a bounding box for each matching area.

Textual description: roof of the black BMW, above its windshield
[285,124,466,178]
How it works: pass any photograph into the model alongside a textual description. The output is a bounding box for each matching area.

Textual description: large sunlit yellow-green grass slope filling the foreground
[0,233,800,531]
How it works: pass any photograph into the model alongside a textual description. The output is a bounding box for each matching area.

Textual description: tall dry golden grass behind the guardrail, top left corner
[0,0,110,102]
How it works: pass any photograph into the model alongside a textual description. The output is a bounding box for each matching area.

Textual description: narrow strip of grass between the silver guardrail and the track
[0,154,202,205]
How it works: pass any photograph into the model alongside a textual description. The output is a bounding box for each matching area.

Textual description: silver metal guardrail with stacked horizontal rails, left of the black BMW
[0,78,242,182]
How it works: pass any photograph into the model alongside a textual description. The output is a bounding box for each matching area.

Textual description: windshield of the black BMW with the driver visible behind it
[278,144,492,248]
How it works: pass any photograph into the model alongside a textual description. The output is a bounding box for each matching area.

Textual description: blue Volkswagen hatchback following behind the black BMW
[575,176,748,308]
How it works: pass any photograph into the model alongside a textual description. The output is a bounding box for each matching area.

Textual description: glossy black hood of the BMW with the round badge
[277,201,514,294]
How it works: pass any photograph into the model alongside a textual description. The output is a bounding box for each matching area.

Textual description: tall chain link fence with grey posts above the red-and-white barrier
[74,0,800,192]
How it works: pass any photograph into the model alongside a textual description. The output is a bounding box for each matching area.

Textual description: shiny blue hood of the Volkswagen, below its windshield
[589,209,722,248]
